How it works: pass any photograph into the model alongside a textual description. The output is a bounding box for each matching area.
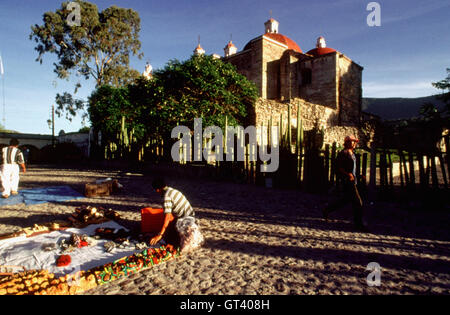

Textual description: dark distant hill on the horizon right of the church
[362,95,444,120]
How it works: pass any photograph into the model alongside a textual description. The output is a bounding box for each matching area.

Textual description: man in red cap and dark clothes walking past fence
[323,136,367,231]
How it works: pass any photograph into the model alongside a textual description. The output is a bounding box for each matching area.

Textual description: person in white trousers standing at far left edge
[0,138,27,198]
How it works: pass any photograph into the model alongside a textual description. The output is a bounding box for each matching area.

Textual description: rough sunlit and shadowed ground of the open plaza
[0,166,450,295]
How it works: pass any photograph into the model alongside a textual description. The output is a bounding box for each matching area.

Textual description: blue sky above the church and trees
[0,0,450,134]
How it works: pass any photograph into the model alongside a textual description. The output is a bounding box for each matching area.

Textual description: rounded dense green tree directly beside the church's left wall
[149,56,258,128]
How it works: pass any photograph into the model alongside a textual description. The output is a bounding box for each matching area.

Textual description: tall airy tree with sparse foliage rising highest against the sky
[30,0,142,120]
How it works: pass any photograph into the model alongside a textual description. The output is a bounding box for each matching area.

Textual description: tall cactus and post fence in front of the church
[100,112,450,198]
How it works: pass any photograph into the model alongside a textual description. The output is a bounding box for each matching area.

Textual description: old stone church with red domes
[194,18,363,148]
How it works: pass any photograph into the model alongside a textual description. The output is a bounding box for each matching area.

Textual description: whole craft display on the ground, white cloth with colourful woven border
[0,207,180,295]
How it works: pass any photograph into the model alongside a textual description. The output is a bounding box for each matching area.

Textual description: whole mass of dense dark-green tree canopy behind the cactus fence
[89,56,258,147]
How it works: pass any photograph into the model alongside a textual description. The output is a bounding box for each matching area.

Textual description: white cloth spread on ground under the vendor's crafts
[0,221,152,276]
